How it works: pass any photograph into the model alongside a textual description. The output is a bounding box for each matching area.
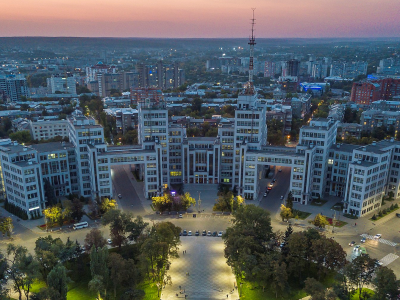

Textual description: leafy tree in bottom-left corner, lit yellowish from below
[7,244,38,300]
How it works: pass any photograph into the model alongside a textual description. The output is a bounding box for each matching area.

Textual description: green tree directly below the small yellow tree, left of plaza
[102,209,133,249]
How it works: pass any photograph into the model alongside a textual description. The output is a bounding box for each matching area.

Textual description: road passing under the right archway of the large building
[259,166,291,214]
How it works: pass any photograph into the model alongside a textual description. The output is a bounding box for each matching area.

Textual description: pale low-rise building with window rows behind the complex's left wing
[29,120,69,141]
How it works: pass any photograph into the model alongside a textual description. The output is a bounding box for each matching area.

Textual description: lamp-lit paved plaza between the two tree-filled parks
[160,236,239,300]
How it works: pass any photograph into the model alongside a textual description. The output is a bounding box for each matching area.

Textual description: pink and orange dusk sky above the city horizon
[0,0,400,38]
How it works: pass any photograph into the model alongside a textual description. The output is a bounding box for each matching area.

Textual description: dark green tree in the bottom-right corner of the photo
[372,267,400,300]
